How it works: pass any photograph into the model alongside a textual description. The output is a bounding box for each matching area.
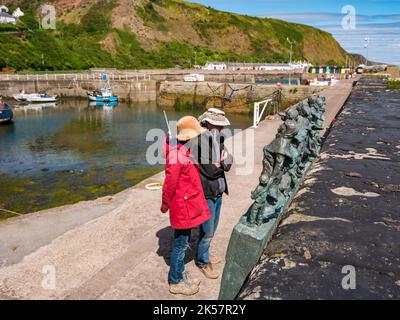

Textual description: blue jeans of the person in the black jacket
[196,196,222,268]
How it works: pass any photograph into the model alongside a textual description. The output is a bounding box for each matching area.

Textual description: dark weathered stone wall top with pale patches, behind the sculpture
[240,78,400,300]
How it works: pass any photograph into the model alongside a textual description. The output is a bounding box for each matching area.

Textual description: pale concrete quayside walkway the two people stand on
[0,81,352,299]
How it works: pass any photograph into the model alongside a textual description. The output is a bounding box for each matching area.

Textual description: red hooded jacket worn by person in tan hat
[161,142,211,229]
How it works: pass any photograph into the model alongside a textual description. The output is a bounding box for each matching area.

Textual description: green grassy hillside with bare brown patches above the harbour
[0,0,345,70]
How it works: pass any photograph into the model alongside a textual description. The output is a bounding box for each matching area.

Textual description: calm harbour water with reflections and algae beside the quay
[0,100,252,215]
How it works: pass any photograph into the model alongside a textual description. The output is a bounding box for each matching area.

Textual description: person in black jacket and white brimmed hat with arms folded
[192,108,233,279]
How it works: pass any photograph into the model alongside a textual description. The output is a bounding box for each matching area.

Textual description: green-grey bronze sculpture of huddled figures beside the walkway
[246,96,326,226]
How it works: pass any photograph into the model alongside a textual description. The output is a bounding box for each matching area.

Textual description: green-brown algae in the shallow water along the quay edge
[0,166,162,221]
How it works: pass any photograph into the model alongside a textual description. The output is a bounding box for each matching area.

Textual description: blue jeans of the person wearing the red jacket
[168,229,192,284]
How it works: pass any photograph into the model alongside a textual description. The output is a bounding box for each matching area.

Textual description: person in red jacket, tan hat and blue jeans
[161,117,211,295]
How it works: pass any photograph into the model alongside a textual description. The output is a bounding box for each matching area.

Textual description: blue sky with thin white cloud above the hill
[190,0,400,66]
